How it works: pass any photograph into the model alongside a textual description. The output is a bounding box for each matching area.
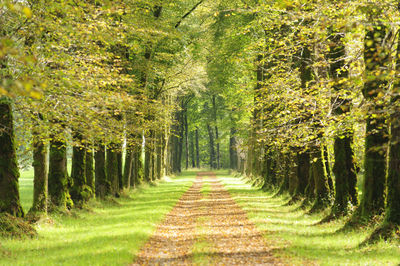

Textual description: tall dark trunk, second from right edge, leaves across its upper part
[358,24,390,220]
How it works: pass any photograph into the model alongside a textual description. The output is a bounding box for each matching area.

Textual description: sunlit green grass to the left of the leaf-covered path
[0,172,195,265]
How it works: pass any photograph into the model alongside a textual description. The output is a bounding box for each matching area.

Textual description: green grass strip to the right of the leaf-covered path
[219,172,400,265]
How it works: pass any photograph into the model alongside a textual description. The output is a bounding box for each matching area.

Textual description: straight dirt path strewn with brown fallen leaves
[133,172,283,265]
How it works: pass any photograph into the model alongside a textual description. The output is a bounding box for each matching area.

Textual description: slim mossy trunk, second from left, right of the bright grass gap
[29,130,48,213]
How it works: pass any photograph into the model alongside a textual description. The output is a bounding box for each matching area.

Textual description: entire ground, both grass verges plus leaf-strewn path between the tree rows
[0,170,400,265]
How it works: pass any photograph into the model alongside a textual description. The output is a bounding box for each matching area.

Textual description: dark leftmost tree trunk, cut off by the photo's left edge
[0,97,24,217]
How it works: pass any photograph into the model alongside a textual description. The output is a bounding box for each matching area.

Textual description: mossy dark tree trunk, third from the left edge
[48,140,70,211]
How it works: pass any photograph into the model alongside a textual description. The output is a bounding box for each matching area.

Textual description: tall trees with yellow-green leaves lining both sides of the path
[0,0,400,245]
